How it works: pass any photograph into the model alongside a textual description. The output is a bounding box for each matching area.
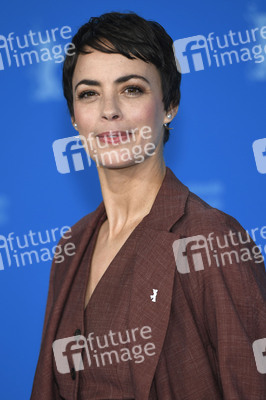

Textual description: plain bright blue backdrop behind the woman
[0,0,266,400]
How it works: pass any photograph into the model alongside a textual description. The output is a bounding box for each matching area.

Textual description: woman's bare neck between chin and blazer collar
[98,160,166,239]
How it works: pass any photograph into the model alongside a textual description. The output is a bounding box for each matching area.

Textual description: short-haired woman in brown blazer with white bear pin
[31,13,266,400]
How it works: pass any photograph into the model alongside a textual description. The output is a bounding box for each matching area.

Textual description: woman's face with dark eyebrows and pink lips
[72,47,174,168]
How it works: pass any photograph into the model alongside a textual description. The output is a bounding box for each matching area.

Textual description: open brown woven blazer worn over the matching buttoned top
[31,168,266,400]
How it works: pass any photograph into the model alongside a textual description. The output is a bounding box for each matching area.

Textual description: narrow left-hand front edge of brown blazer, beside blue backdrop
[31,203,106,400]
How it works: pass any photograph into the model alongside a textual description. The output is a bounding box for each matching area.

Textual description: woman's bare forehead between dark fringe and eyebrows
[73,46,160,85]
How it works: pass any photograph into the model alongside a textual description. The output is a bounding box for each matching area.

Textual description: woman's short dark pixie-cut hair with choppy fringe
[63,12,181,143]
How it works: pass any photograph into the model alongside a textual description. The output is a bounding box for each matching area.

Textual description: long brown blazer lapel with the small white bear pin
[129,168,189,400]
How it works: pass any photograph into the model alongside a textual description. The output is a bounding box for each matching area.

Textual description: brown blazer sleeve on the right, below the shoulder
[183,223,266,400]
